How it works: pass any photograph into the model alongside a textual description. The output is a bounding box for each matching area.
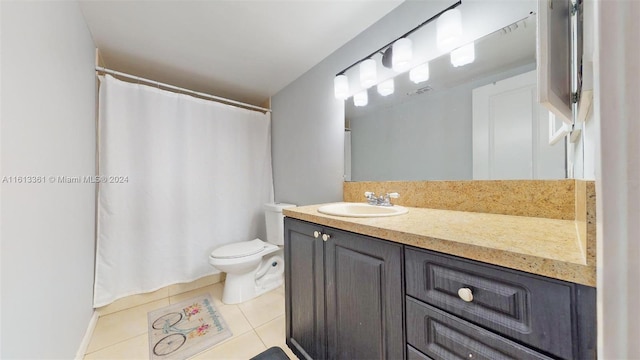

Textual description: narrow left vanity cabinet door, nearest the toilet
[284,218,326,359]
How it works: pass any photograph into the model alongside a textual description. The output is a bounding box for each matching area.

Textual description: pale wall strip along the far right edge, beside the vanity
[594,1,640,359]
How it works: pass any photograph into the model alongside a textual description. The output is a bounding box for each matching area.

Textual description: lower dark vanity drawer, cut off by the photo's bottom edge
[407,297,550,360]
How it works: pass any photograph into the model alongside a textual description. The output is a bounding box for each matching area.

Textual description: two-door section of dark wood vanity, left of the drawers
[285,218,405,360]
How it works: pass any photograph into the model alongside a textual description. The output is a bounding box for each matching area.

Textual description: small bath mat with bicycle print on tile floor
[147,295,232,360]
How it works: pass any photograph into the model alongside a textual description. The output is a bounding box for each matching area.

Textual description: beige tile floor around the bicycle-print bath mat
[84,283,297,360]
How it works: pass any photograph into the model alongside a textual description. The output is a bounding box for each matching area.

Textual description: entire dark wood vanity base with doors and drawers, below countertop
[285,218,596,360]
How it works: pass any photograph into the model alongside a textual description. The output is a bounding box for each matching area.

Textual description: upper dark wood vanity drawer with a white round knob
[405,248,577,359]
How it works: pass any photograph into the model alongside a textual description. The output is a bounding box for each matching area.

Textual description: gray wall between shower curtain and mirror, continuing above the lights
[271,1,452,205]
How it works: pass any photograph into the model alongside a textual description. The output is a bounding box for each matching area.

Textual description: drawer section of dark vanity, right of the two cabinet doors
[405,247,596,359]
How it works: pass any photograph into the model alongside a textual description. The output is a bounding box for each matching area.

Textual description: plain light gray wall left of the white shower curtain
[0,1,95,359]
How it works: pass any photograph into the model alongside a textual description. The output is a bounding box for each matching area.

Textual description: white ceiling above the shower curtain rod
[80,0,403,106]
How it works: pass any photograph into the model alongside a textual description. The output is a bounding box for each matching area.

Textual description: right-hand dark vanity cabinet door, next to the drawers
[324,229,404,360]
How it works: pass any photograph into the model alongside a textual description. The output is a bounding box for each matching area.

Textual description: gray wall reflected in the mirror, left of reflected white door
[349,63,535,181]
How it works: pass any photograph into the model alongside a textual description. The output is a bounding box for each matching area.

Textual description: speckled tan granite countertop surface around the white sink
[284,204,596,286]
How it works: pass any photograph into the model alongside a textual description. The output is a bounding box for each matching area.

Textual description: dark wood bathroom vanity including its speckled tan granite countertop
[285,201,596,359]
